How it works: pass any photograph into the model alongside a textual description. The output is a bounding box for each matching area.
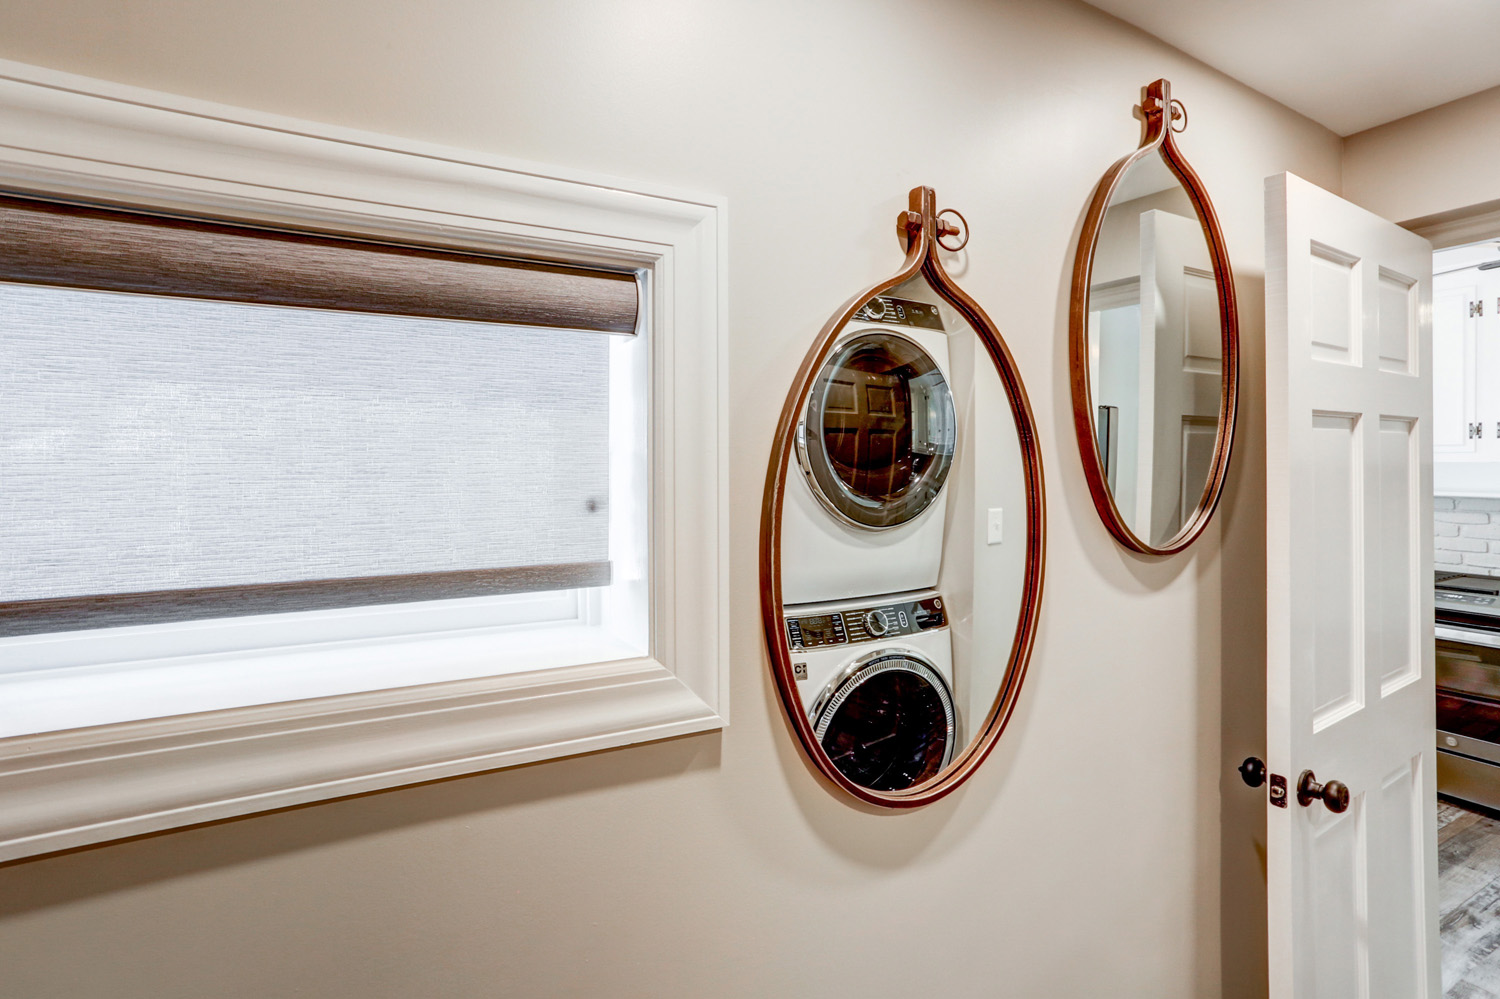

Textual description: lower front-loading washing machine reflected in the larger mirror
[785,591,959,791]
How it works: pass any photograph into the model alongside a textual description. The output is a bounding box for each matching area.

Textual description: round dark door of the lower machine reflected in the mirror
[810,650,956,791]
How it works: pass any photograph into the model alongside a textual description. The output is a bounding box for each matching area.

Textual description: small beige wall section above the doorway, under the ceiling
[1344,87,1500,225]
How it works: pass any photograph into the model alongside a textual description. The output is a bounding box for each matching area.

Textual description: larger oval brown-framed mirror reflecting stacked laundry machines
[761,188,1044,807]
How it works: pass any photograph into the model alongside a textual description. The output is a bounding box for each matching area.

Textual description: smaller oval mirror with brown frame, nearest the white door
[1070,80,1239,555]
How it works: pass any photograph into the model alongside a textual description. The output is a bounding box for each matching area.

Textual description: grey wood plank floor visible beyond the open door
[1437,800,1500,999]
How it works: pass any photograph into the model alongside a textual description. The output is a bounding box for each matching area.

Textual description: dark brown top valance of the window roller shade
[0,195,639,333]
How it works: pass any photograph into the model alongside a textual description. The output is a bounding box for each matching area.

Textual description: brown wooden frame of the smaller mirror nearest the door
[1068,80,1239,555]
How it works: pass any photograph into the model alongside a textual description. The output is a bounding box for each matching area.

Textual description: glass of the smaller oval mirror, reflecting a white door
[1088,150,1224,548]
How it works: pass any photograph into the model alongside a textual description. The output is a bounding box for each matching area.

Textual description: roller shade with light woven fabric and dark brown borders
[0,198,635,636]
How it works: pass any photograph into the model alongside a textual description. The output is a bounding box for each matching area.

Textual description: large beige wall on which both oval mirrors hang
[0,0,1341,999]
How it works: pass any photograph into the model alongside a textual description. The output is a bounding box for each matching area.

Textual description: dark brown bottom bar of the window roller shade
[0,563,611,638]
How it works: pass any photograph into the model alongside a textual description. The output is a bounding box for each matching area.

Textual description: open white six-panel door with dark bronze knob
[1266,174,1442,999]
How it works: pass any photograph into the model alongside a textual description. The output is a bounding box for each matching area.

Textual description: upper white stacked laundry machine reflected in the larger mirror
[782,297,957,603]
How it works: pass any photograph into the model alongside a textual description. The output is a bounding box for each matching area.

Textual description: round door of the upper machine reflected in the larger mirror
[798,332,957,528]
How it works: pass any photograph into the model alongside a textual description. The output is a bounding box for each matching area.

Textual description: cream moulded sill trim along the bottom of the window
[0,659,723,861]
